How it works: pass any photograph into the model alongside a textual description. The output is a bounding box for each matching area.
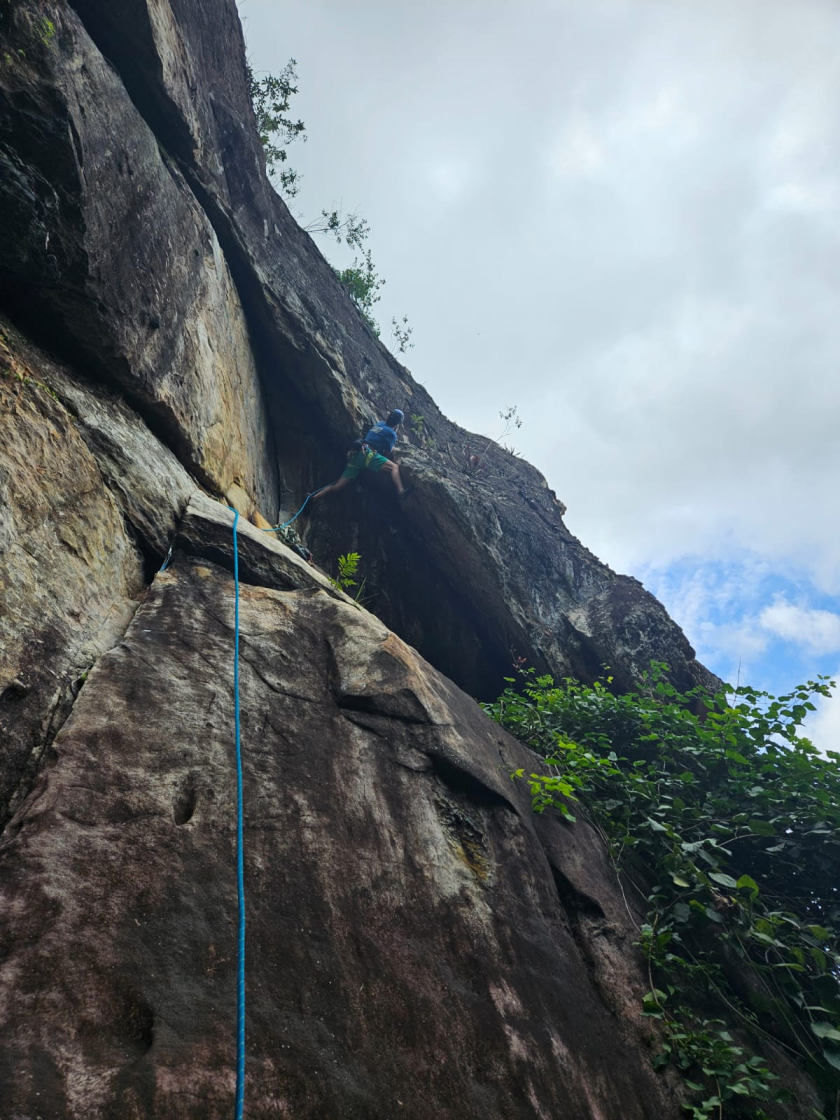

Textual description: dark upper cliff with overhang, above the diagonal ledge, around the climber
[0,0,725,699]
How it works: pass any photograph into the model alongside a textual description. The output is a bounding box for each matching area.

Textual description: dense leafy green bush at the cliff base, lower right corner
[486,663,840,1120]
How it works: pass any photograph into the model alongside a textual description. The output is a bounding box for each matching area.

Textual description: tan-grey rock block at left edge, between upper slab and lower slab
[0,317,196,828]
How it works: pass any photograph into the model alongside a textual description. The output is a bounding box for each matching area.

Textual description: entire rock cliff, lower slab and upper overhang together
[0,0,811,1120]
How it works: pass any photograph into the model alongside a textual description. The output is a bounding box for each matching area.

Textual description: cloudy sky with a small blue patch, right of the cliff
[240,0,840,749]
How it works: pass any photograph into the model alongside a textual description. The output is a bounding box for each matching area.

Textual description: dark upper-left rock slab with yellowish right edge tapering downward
[0,0,277,512]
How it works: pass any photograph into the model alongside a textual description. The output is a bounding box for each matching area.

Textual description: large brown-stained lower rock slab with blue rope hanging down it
[0,499,679,1120]
